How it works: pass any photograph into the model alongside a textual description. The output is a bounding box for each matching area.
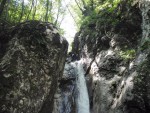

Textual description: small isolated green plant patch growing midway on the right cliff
[119,49,136,60]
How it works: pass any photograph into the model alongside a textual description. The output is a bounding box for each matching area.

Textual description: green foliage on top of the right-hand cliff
[73,0,121,29]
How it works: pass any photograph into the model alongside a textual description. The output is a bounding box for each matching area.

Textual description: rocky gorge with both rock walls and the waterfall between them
[0,0,150,113]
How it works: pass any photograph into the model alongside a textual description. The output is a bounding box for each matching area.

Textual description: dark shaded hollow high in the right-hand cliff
[114,5,142,46]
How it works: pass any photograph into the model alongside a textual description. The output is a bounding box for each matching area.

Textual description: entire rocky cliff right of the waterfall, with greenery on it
[73,0,150,113]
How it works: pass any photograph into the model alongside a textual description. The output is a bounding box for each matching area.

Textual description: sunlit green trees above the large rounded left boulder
[0,0,66,27]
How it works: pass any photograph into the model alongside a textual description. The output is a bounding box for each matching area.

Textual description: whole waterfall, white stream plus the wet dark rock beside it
[52,60,90,113]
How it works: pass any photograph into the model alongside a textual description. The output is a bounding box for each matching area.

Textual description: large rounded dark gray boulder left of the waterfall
[0,21,68,113]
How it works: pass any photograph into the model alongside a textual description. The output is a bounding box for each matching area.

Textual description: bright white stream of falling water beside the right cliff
[76,60,90,113]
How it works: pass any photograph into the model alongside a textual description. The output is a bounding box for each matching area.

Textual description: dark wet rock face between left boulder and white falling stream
[53,62,78,113]
